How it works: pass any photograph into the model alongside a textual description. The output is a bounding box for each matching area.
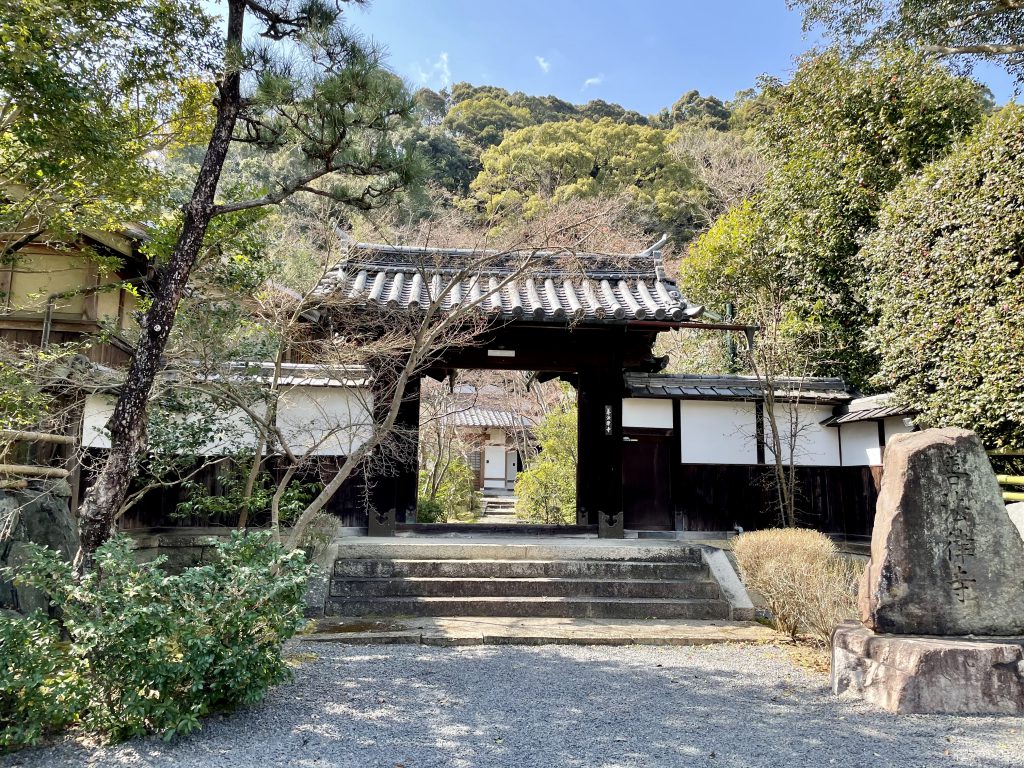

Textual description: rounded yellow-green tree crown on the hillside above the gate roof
[471,118,692,230]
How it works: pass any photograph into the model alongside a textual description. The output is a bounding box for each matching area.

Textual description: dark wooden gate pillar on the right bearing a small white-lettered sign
[577,355,623,530]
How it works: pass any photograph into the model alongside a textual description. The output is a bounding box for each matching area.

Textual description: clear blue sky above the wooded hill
[348,0,1013,114]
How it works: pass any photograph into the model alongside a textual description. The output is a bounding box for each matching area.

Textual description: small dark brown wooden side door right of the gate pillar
[623,431,675,530]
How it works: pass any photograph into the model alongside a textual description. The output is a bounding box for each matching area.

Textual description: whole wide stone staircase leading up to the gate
[325,540,730,620]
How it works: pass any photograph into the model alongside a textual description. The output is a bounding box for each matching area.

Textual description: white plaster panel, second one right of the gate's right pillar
[679,400,758,464]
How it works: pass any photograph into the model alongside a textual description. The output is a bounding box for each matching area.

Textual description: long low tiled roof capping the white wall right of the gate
[626,373,853,404]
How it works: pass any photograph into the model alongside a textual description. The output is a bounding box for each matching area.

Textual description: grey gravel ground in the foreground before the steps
[0,644,1024,768]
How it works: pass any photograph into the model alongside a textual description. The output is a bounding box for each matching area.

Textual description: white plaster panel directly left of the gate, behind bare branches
[278,386,373,456]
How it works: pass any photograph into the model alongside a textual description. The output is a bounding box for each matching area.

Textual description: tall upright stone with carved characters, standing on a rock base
[860,429,1024,636]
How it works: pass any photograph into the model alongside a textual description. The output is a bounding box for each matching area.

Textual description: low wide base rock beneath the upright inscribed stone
[831,622,1024,715]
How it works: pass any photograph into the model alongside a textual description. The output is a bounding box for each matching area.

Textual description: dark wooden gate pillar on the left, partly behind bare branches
[371,372,420,522]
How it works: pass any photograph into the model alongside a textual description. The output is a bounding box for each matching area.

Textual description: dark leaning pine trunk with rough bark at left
[76,0,246,573]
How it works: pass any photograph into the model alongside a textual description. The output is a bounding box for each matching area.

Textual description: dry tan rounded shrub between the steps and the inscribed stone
[732,528,863,644]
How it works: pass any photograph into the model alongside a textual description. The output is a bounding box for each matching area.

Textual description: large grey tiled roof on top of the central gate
[317,243,703,323]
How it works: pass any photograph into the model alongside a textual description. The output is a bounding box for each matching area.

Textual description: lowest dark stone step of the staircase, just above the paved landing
[327,596,729,620]
